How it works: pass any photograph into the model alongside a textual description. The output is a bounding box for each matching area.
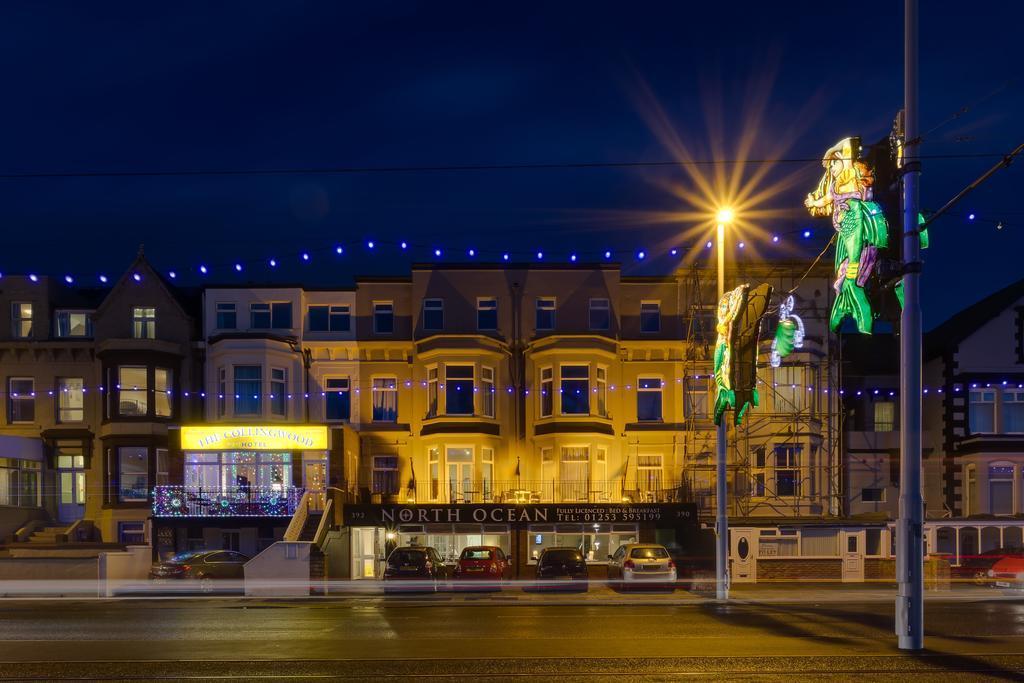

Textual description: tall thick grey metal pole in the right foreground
[896,0,925,650]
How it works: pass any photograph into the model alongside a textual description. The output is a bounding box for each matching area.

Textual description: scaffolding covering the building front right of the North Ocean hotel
[680,263,843,520]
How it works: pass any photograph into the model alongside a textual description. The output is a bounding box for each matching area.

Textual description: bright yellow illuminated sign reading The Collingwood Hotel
[181,425,329,451]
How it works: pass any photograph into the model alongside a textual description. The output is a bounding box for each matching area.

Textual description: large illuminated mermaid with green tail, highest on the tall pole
[804,137,899,335]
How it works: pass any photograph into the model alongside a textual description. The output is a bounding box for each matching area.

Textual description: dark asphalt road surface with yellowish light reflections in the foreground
[0,595,1024,681]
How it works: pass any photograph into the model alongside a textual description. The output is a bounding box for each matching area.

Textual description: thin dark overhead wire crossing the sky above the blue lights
[0,153,1002,180]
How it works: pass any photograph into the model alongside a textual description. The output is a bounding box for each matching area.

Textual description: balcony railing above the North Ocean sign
[376,479,690,504]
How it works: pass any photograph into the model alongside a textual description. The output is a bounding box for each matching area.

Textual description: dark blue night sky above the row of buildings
[0,0,1024,327]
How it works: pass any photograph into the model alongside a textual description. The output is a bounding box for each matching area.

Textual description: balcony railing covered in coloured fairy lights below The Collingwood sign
[153,486,304,517]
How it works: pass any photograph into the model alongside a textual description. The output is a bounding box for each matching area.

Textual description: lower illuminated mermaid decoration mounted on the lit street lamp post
[715,285,772,425]
